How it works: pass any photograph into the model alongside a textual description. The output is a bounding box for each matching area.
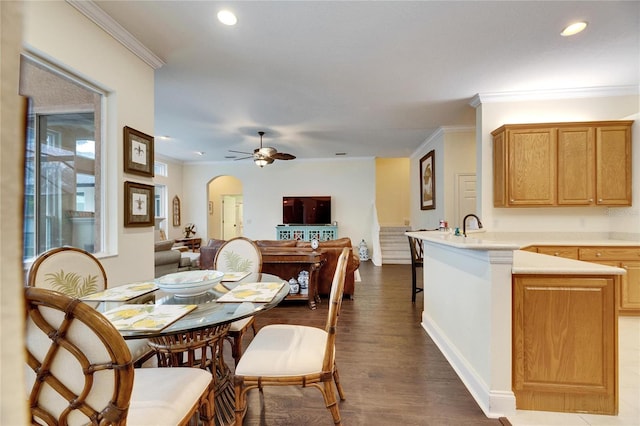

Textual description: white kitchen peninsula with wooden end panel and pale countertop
[407,231,638,417]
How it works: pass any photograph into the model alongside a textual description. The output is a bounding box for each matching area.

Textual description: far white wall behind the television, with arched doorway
[183,158,375,245]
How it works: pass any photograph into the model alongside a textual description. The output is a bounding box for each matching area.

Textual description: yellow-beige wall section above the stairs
[376,158,410,226]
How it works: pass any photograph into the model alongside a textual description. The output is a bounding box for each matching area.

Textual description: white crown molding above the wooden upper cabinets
[469,86,640,108]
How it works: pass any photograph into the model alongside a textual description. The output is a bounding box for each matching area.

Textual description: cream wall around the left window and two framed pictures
[23,1,154,286]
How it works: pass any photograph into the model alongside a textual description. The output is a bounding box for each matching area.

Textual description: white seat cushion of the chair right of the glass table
[236,324,327,377]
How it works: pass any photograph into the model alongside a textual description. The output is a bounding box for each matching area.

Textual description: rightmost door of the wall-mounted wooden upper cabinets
[596,126,631,206]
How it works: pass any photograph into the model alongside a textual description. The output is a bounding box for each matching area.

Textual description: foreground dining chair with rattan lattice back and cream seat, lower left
[24,287,214,426]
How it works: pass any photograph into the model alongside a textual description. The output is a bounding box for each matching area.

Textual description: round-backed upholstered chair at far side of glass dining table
[213,237,262,365]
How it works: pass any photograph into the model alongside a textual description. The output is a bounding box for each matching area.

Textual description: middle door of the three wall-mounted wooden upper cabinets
[558,127,596,206]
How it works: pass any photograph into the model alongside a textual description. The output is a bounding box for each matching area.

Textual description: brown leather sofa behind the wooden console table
[200,238,360,298]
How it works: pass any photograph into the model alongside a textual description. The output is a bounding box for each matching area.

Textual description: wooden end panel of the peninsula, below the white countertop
[513,275,618,415]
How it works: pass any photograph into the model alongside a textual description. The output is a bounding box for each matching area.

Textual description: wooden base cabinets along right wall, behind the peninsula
[526,246,640,316]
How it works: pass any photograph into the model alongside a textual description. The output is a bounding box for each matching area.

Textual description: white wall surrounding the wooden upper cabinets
[476,94,640,240]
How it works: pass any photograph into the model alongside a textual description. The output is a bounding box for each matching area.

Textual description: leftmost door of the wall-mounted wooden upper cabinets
[507,128,557,206]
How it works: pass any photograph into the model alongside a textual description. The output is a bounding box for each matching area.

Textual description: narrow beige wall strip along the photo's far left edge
[0,2,28,425]
